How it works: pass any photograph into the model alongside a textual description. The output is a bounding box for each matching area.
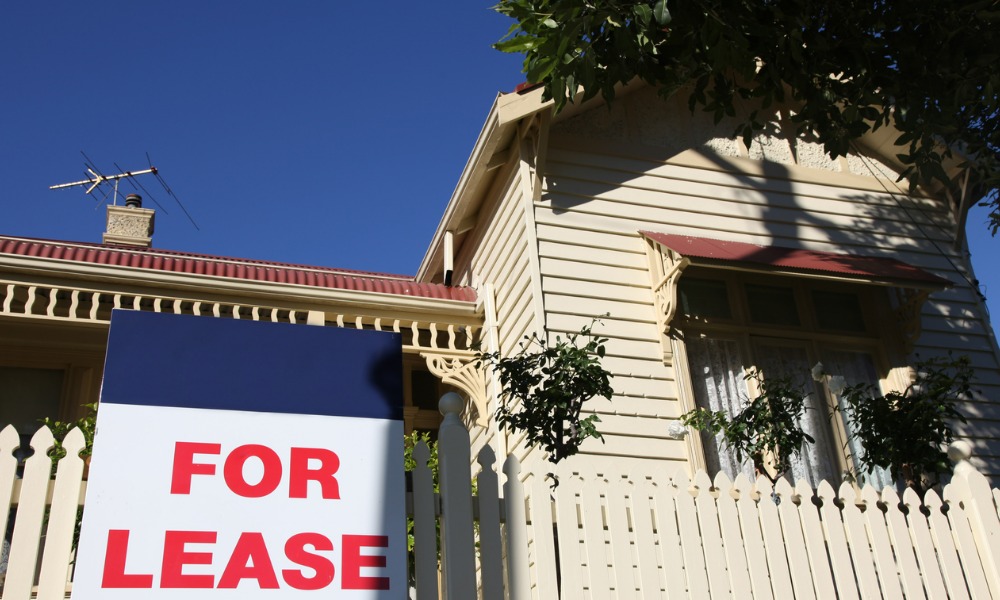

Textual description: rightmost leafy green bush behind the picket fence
[843,356,972,494]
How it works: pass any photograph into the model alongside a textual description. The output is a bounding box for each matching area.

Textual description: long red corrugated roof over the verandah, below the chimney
[0,236,476,302]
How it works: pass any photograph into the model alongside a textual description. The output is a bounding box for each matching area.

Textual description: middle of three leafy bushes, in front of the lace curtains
[681,370,815,482]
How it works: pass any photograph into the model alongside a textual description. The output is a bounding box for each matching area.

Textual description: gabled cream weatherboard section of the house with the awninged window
[417,85,1000,485]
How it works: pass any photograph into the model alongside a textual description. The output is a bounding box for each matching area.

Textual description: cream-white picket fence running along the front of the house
[0,397,1000,600]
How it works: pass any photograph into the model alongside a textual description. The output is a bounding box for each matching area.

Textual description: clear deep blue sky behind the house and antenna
[0,0,1000,328]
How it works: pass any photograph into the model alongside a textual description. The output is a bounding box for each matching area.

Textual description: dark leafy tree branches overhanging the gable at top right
[494,0,1000,230]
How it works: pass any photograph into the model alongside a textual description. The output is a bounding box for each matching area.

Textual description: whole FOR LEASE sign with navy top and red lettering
[72,311,406,600]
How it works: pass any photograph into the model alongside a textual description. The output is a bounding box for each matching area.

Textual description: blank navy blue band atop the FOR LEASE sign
[101,310,403,420]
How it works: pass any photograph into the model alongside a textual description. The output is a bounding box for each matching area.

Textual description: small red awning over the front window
[639,231,951,287]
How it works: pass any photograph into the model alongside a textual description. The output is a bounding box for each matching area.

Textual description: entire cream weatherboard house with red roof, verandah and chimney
[0,85,1000,598]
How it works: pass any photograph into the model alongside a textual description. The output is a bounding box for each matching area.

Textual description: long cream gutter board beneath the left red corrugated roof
[0,256,478,318]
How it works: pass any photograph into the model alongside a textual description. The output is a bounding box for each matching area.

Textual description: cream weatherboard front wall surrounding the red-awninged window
[536,94,1000,476]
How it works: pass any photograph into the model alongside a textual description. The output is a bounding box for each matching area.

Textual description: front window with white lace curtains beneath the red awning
[674,267,904,486]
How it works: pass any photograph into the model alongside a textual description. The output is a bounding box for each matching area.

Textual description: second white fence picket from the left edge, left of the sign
[3,427,53,600]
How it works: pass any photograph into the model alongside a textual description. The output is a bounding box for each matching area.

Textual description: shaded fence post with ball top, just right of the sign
[438,392,476,600]
